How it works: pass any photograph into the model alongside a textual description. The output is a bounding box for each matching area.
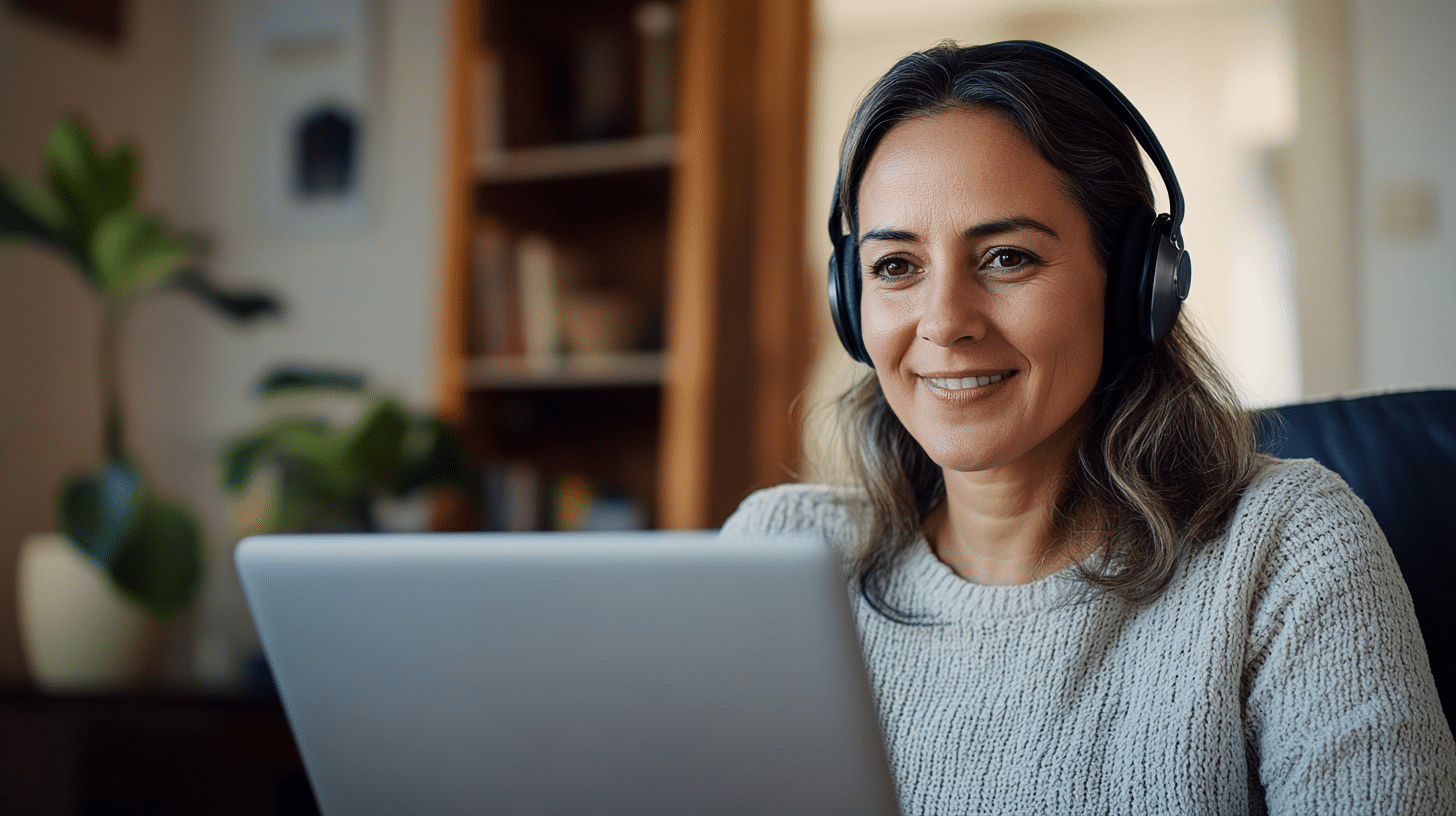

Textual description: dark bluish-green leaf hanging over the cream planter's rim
[60,459,147,568]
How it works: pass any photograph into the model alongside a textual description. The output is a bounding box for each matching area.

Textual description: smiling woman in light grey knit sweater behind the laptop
[725,44,1456,815]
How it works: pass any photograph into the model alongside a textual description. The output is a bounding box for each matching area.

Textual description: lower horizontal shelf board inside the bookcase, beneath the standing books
[466,351,664,391]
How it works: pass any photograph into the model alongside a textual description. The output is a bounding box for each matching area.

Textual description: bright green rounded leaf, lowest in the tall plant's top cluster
[90,205,189,300]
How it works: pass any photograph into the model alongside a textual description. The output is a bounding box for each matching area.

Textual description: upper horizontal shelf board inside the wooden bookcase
[475,136,677,185]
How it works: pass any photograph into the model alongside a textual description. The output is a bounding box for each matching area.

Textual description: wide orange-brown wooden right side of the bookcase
[658,0,811,527]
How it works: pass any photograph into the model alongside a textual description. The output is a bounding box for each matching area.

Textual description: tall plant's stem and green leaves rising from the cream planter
[0,117,280,681]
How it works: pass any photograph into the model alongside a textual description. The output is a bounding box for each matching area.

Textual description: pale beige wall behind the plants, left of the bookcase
[0,0,448,683]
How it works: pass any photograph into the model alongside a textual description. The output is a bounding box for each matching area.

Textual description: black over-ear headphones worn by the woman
[828,39,1191,364]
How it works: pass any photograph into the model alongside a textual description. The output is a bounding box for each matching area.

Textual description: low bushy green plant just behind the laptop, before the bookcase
[223,369,479,532]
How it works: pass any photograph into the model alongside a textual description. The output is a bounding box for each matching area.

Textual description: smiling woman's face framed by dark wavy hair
[859,109,1104,472]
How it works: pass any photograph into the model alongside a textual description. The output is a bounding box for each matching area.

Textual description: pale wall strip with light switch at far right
[1350,0,1456,388]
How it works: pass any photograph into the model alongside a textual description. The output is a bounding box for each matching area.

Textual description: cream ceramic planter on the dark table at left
[17,533,165,692]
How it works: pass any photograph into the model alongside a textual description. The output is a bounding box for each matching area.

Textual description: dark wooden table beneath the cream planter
[0,688,319,816]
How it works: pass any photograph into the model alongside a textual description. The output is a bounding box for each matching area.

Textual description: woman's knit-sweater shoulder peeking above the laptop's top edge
[722,484,868,546]
